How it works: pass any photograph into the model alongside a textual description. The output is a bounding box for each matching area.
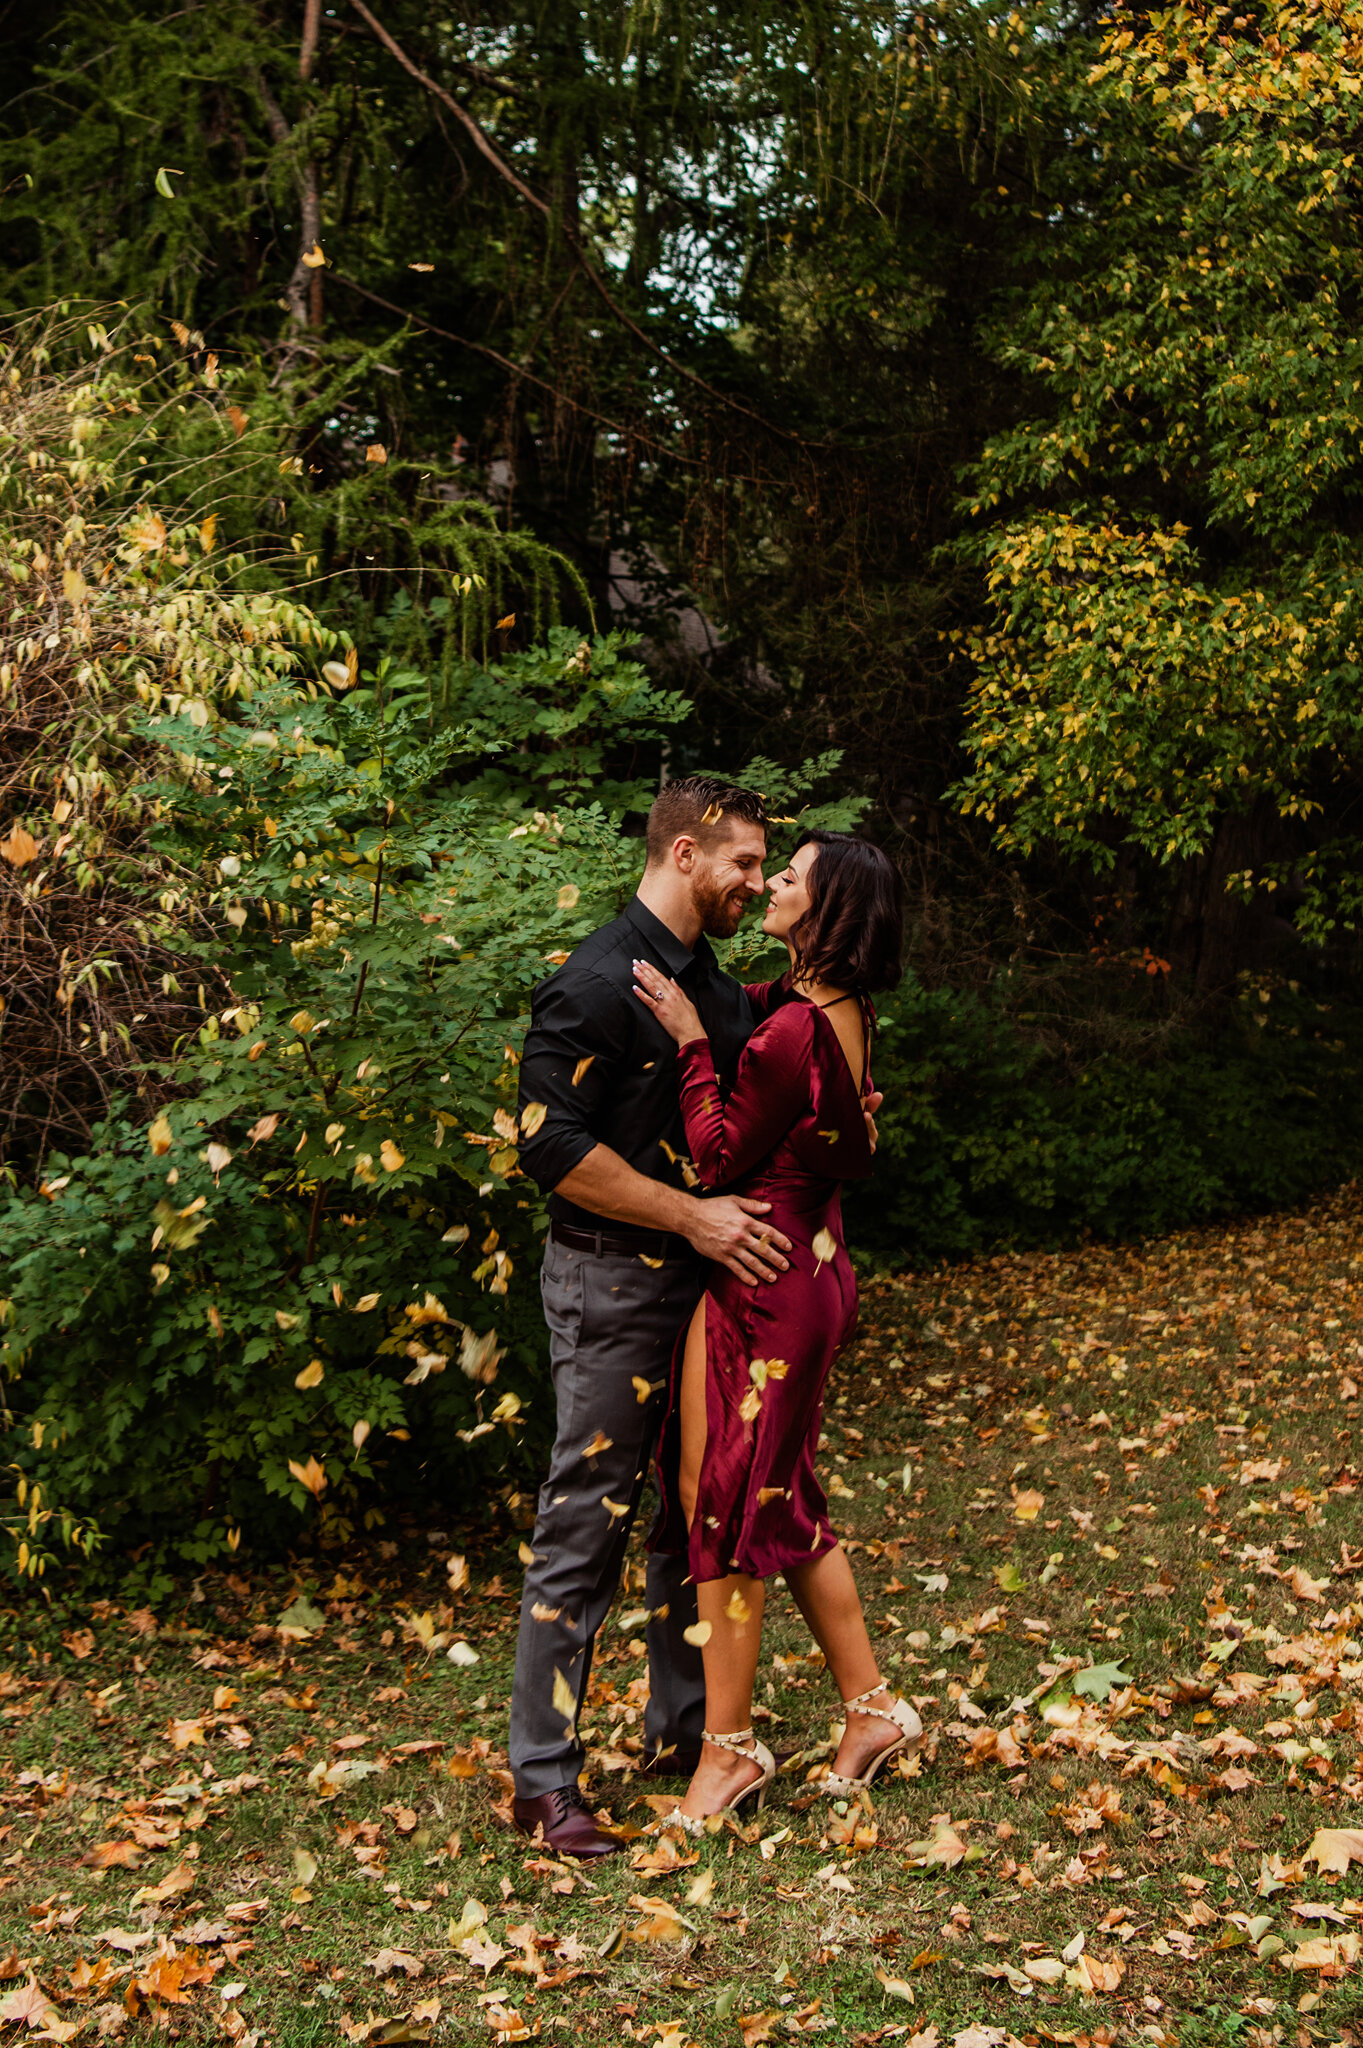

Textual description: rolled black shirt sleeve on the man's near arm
[518,971,634,1194]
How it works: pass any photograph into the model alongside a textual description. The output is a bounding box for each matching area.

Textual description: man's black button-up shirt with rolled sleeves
[520,897,755,1231]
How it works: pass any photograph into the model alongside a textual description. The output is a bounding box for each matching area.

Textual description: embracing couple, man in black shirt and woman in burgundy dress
[499,776,921,1855]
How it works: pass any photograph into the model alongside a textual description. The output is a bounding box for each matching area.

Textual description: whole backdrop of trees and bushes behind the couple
[0,0,1363,1585]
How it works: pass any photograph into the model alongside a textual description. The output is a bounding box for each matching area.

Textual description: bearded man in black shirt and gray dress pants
[510,776,790,1855]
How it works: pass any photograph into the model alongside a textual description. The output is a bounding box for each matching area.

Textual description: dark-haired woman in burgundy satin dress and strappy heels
[634,831,923,1833]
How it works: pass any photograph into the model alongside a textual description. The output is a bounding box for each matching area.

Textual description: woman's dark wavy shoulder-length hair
[790,831,905,995]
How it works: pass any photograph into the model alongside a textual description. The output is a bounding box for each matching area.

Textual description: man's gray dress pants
[510,1237,706,1798]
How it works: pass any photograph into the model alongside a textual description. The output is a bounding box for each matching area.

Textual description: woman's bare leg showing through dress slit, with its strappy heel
[677,1294,765,1815]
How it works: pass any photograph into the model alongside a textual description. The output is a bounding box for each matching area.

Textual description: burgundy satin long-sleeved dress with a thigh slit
[653,983,872,1581]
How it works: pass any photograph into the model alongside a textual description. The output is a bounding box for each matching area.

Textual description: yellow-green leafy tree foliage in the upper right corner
[958,6,1363,936]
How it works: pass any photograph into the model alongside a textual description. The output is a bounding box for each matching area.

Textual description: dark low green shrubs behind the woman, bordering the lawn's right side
[845,979,1363,1264]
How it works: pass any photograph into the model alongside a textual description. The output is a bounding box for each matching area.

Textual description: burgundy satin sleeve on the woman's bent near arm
[677,1004,815,1188]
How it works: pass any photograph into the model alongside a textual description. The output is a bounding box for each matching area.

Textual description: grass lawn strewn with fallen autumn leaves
[0,1192,1363,2048]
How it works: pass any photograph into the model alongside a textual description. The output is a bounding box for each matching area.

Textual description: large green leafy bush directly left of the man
[0,629,679,1563]
